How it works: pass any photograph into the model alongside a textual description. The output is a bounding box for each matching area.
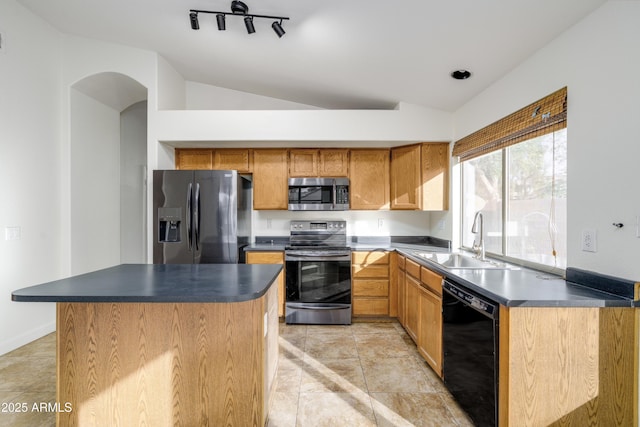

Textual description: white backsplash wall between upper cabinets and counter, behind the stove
[252,211,438,238]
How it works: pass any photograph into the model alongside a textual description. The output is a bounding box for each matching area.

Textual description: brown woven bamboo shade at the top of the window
[452,87,567,161]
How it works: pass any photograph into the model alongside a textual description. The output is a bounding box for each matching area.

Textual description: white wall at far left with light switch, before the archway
[0,0,66,354]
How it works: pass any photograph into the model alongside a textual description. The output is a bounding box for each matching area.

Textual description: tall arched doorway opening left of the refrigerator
[69,72,147,274]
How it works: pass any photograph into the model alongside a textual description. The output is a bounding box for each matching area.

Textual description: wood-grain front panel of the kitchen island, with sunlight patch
[57,294,277,427]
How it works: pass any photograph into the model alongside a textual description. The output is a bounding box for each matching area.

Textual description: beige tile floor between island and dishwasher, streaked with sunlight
[268,322,473,427]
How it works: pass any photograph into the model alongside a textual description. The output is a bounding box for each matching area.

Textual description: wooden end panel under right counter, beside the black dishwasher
[499,307,638,426]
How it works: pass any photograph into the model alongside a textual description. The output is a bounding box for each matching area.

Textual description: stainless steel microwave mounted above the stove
[289,178,349,211]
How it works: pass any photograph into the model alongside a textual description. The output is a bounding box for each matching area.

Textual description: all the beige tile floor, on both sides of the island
[0,322,473,427]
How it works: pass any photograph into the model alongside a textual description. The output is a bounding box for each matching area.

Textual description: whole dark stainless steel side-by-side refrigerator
[153,170,251,264]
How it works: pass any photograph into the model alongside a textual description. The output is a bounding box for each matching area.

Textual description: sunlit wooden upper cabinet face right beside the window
[420,142,449,211]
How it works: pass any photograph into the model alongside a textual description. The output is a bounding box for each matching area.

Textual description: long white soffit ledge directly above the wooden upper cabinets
[157,103,453,146]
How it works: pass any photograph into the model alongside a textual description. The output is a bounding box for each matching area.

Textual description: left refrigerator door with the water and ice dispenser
[153,170,194,264]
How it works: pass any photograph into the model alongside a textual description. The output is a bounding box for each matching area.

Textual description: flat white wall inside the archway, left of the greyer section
[70,89,120,274]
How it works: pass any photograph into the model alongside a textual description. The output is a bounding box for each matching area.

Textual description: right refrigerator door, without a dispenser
[193,170,238,264]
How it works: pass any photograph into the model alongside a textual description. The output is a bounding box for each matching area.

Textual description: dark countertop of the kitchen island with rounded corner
[11,264,282,303]
